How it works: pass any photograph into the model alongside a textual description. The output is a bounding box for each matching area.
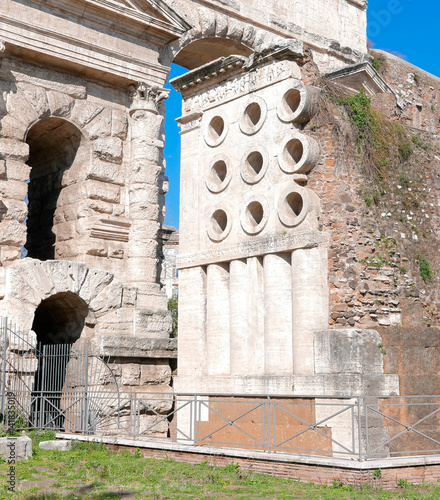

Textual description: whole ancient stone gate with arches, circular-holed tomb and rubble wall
[0,0,440,456]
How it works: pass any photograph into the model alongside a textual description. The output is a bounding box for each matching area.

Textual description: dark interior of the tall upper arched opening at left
[25,118,82,260]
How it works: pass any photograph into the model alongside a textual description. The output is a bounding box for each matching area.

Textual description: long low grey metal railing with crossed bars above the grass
[4,391,440,461]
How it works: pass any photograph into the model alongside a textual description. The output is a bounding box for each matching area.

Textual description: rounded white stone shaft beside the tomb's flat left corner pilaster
[206,264,231,375]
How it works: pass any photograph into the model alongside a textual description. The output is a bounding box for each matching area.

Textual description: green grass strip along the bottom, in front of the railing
[0,440,440,500]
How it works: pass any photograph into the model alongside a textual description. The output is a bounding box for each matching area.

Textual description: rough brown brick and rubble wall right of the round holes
[302,50,440,328]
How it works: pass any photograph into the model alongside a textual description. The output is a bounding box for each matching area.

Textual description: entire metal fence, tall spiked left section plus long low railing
[0,320,440,461]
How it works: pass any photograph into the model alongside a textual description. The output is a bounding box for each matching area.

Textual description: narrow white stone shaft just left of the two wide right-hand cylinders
[247,257,264,376]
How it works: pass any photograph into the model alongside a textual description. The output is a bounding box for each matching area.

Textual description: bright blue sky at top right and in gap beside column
[165,0,440,227]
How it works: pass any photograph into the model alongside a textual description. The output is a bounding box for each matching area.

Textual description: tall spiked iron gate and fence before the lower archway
[0,318,122,434]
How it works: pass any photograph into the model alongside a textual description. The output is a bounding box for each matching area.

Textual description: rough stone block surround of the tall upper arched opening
[0,75,122,267]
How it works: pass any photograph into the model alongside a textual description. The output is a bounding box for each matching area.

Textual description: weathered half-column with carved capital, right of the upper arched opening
[127,83,168,320]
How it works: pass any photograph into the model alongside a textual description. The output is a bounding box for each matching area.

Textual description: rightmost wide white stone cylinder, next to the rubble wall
[292,247,329,375]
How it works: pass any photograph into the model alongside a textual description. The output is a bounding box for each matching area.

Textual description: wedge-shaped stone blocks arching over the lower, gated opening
[0,258,122,338]
